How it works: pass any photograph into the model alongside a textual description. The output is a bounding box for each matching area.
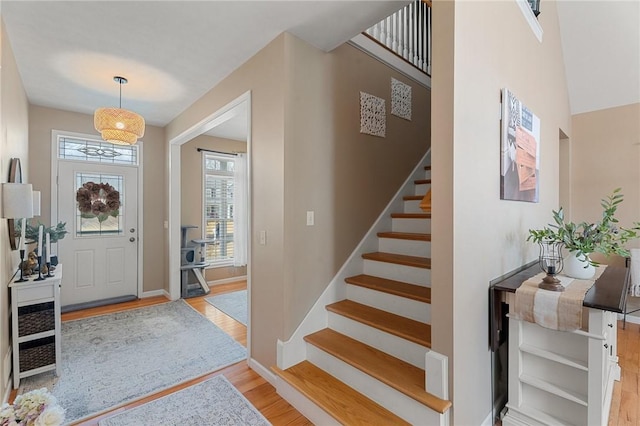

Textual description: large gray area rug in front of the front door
[20,300,246,422]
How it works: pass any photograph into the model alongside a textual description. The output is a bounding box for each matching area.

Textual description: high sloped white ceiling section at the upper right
[556,0,640,115]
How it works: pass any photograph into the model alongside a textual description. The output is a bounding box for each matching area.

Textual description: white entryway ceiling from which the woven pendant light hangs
[1,0,408,126]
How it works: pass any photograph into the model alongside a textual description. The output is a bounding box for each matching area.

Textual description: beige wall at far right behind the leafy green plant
[571,103,640,256]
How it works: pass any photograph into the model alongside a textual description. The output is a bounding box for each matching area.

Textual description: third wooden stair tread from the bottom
[326,300,431,348]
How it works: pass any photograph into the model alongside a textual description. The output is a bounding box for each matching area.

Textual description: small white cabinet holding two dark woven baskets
[9,265,62,389]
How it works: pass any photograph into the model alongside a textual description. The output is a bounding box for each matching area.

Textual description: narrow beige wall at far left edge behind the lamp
[0,17,33,400]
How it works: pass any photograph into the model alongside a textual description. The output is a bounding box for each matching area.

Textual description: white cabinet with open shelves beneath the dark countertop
[503,308,620,426]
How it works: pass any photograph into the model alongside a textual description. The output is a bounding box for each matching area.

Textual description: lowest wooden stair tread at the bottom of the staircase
[272,361,409,426]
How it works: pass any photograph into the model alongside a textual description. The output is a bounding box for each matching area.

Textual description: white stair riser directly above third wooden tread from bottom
[347,284,431,324]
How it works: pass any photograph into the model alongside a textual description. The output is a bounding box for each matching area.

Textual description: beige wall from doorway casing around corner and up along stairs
[167,34,429,367]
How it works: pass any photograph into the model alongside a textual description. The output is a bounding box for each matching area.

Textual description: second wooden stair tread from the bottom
[304,328,451,413]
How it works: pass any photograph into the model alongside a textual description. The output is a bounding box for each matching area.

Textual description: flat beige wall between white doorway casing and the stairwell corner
[166,35,285,367]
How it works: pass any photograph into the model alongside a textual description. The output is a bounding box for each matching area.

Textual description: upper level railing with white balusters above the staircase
[365,0,431,76]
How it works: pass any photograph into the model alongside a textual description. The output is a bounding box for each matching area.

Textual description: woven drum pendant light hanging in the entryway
[93,76,144,145]
